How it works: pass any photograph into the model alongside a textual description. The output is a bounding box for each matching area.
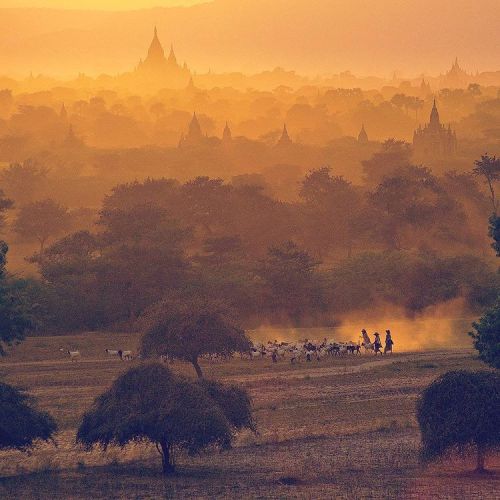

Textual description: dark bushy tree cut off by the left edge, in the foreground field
[0,382,57,451]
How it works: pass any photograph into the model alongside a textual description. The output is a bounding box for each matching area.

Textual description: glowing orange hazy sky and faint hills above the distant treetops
[0,0,500,78]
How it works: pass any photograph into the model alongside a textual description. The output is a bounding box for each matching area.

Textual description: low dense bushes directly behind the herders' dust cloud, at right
[326,251,500,313]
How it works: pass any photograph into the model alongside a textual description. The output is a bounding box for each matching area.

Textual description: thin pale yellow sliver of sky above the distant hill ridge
[1,0,205,10]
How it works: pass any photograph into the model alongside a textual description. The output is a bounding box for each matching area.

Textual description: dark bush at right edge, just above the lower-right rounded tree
[469,299,500,368]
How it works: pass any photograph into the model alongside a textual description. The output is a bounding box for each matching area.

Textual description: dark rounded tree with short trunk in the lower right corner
[417,370,500,472]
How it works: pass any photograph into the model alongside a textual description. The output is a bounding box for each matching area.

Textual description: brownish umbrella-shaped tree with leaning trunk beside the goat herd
[141,299,250,378]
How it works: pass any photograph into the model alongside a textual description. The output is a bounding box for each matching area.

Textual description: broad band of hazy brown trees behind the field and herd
[0,145,492,329]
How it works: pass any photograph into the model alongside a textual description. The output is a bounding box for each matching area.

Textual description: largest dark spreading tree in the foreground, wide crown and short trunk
[77,363,251,474]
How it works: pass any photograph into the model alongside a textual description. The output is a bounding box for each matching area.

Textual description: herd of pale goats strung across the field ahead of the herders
[59,339,386,364]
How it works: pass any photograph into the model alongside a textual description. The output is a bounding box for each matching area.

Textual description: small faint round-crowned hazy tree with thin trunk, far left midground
[13,200,71,258]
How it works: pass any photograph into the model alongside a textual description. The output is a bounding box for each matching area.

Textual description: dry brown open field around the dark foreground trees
[0,333,500,499]
